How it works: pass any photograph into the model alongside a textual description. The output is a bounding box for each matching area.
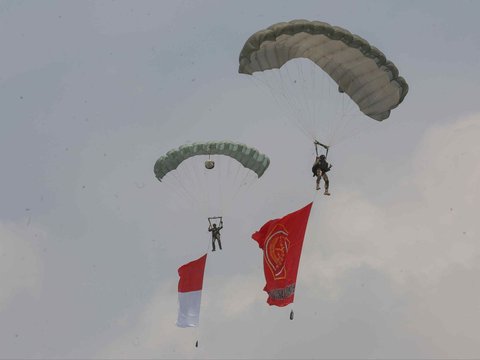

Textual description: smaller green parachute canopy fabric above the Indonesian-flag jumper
[154,141,270,181]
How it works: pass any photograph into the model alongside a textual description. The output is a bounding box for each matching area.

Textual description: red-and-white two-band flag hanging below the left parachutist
[177,254,207,327]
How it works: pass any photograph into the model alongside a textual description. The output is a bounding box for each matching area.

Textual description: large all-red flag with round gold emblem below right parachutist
[252,203,312,306]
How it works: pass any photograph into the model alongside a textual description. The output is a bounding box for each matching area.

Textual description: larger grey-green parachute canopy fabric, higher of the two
[238,20,408,121]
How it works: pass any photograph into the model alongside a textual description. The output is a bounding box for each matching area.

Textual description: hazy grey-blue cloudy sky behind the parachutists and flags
[0,0,480,359]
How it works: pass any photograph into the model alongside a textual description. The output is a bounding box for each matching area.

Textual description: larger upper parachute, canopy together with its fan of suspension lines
[238,20,408,146]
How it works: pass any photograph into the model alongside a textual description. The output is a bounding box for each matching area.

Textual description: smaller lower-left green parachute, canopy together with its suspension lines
[154,141,270,217]
